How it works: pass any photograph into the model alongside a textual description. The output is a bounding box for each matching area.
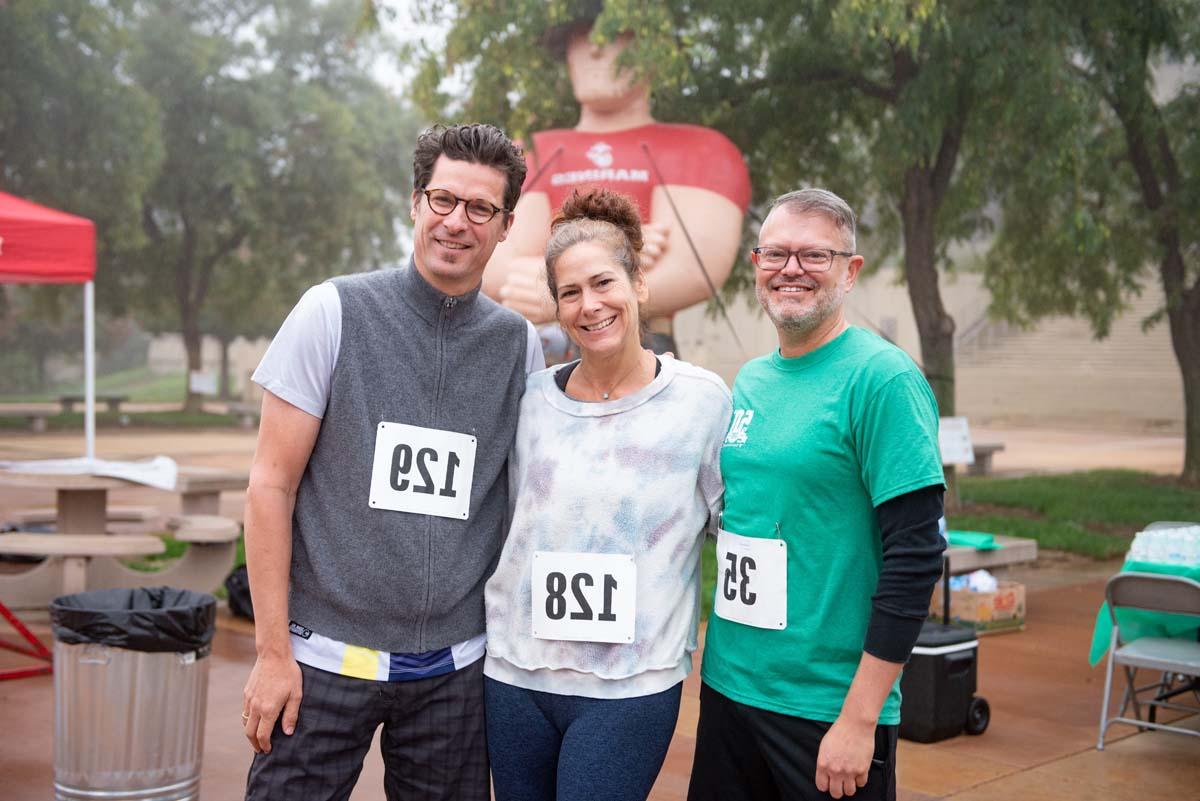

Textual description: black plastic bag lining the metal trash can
[50,586,217,656]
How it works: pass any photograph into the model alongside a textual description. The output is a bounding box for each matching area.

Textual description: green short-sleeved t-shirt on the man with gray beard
[701,327,943,724]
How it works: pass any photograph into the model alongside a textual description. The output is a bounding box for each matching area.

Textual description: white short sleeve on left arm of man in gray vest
[251,283,342,418]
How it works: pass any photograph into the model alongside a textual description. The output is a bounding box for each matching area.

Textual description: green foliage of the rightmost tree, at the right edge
[986,0,1200,483]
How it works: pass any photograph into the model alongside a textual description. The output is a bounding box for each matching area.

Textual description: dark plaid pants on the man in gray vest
[246,660,490,801]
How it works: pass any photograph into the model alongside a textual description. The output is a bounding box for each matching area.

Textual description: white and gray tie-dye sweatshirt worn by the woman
[484,359,731,698]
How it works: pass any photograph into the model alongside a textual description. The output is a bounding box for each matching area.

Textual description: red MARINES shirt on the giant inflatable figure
[522,122,750,219]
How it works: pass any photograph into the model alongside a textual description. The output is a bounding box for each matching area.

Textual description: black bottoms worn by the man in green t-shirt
[688,683,900,801]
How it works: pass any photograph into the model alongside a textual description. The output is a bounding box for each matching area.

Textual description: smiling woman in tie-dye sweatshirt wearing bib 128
[485,189,731,801]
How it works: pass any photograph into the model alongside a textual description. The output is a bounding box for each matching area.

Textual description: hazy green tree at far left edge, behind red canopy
[0,0,162,369]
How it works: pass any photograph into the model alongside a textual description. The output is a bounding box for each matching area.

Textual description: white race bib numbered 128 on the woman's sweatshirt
[530,550,637,643]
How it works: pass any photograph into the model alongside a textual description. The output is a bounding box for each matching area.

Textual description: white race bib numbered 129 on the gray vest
[370,422,475,520]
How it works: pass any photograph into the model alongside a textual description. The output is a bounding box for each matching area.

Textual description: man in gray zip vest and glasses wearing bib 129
[241,125,542,801]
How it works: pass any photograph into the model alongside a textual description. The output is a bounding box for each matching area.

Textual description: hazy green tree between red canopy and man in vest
[127,0,414,409]
